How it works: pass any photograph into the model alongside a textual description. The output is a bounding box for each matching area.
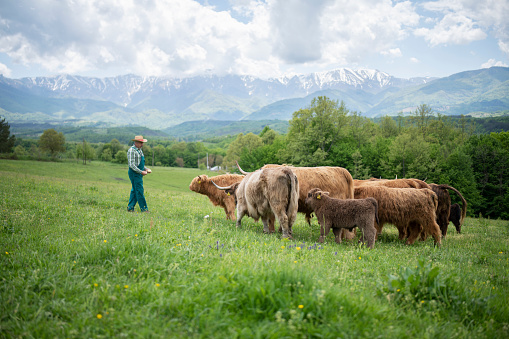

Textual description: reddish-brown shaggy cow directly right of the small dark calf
[354,185,441,245]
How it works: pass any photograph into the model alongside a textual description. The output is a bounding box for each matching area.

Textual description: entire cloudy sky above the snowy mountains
[0,0,509,78]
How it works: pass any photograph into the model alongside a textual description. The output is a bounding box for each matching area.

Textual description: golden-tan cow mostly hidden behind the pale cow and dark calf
[237,163,355,239]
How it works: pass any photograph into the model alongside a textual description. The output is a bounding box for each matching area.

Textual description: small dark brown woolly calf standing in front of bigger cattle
[306,188,379,248]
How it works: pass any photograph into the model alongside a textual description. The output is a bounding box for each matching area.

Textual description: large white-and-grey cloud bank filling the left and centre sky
[0,0,419,76]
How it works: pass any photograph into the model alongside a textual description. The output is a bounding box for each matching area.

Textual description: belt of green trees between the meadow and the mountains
[1,97,509,220]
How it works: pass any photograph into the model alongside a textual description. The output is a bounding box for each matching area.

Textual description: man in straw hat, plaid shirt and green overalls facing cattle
[127,135,152,212]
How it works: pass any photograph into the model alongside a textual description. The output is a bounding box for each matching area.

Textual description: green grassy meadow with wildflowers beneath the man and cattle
[0,160,509,338]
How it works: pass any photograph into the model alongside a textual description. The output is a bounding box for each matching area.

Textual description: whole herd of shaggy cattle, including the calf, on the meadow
[189,163,467,248]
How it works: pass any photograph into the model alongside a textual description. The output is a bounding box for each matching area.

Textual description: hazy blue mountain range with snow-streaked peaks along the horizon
[0,67,509,130]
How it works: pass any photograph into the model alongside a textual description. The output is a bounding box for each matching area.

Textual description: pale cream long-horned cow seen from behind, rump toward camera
[213,168,299,238]
